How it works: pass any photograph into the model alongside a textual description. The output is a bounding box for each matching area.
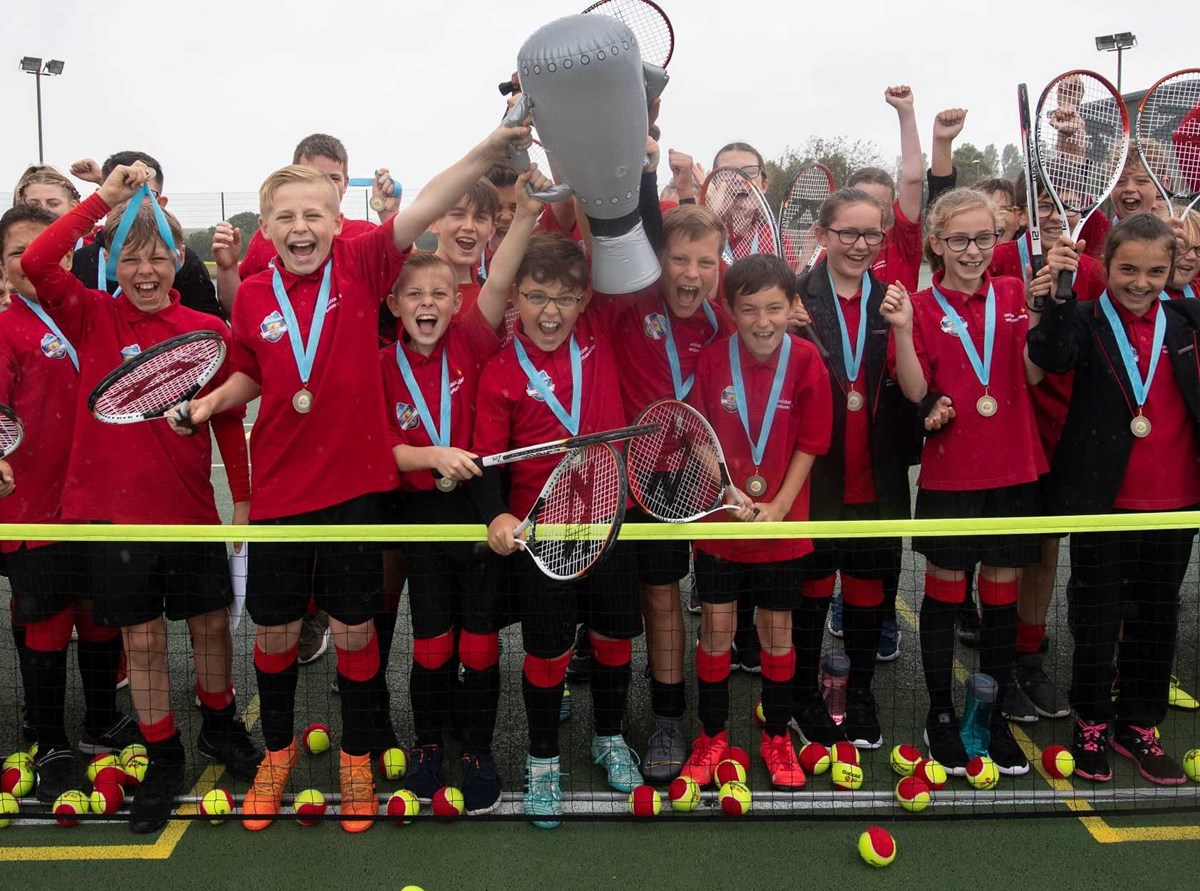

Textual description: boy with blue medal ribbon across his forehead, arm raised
[20,163,262,832]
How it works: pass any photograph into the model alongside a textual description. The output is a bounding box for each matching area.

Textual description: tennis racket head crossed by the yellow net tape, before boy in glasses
[512,442,628,581]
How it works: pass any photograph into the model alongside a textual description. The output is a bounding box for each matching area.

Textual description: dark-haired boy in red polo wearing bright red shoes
[680,255,833,789]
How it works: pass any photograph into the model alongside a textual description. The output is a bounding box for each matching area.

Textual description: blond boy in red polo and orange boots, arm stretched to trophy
[181,120,528,832]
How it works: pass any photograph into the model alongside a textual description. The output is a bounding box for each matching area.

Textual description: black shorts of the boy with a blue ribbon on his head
[90,542,233,628]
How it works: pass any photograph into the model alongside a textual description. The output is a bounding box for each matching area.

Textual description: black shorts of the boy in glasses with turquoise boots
[511,542,642,659]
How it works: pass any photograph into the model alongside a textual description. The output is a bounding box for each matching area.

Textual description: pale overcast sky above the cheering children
[0,0,1200,225]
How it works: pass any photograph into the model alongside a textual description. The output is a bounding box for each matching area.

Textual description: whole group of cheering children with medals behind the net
[0,78,1200,832]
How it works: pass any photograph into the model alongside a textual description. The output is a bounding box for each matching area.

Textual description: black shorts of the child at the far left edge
[5,542,91,624]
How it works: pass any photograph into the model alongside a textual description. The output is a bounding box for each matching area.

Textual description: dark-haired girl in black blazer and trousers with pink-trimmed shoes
[1028,213,1200,785]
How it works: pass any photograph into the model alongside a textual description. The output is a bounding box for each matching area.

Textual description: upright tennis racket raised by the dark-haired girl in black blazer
[1033,70,1129,300]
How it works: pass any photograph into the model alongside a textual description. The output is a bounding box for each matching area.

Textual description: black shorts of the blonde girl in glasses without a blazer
[912,483,1042,573]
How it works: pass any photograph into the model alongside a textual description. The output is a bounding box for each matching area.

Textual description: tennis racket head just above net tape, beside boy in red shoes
[625,399,750,522]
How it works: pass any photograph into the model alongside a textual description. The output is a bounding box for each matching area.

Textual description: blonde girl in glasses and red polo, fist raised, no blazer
[881,189,1046,776]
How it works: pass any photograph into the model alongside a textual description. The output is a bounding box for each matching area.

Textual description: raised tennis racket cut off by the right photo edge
[1134,68,1200,219]
